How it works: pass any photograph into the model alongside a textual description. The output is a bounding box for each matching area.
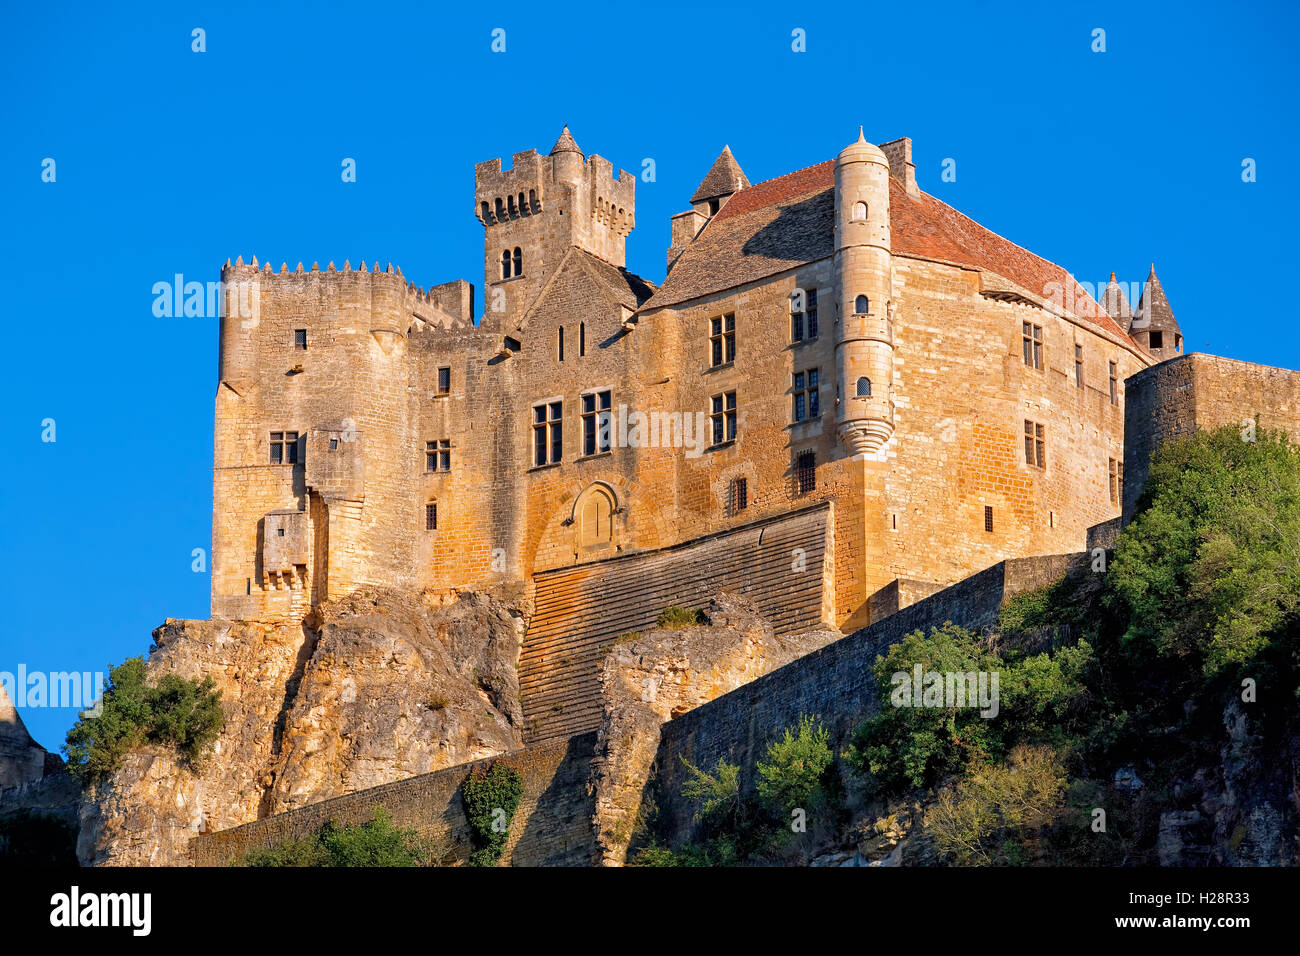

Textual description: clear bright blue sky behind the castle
[0,0,1300,749]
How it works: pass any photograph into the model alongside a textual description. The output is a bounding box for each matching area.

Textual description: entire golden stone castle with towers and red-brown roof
[212,127,1182,642]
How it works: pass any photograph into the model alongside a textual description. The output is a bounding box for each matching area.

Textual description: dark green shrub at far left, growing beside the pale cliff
[64,657,225,783]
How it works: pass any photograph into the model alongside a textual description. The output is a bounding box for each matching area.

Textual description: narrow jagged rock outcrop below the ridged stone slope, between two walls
[592,593,841,866]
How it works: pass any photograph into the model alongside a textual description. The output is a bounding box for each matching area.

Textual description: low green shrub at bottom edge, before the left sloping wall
[243,806,434,866]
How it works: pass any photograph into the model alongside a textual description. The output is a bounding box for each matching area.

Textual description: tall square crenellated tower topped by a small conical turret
[475,126,636,317]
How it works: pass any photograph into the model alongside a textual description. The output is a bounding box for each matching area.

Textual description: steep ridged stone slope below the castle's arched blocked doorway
[519,503,831,744]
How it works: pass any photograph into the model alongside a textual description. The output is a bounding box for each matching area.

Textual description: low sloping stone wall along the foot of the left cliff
[190,732,597,866]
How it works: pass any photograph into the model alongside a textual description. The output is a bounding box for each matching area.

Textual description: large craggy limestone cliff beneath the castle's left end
[78,589,524,865]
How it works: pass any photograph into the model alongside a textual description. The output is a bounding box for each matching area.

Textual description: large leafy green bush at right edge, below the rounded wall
[1106,425,1300,678]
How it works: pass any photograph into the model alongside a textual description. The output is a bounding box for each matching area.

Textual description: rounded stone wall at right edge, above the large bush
[1123,352,1300,524]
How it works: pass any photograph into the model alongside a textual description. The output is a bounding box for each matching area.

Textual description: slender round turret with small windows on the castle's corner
[833,127,893,454]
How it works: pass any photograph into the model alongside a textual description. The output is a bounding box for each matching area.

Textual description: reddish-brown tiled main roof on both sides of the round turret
[645,160,1135,347]
